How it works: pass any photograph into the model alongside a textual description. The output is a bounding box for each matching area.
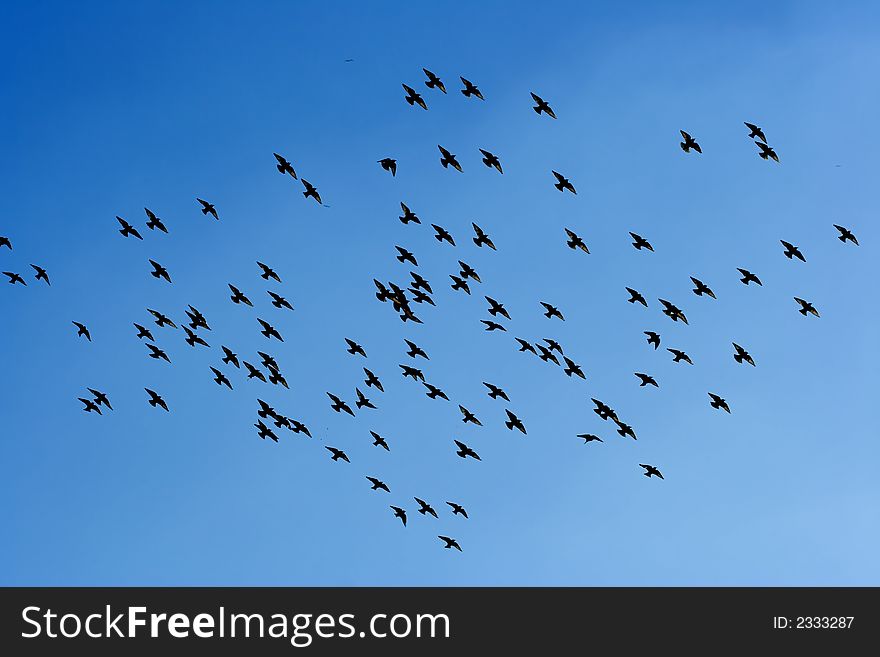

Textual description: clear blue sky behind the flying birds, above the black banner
[0,2,880,585]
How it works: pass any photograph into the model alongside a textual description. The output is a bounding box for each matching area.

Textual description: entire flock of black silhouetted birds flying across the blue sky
[0,69,858,551]
